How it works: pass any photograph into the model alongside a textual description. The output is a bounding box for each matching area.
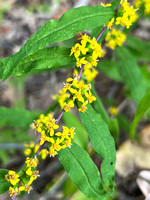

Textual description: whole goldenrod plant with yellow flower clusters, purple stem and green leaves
[0,0,150,200]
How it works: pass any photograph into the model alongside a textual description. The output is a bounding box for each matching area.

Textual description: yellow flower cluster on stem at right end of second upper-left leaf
[70,34,105,68]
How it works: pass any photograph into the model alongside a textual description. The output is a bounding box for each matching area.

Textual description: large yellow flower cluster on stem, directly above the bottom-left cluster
[34,114,75,157]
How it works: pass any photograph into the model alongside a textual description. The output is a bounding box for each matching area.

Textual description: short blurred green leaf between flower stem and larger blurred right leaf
[97,60,122,82]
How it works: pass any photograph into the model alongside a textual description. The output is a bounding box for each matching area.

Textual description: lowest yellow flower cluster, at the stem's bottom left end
[5,157,39,198]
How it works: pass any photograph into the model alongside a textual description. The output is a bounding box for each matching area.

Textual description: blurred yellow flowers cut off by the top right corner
[134,0,150,15]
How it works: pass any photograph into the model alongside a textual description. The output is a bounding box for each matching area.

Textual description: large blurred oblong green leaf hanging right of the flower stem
[115,47,146,103]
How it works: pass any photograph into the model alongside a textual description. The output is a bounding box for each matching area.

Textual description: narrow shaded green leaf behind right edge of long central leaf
[91,87,109,124]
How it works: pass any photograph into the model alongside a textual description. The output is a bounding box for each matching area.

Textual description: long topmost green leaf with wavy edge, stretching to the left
[3,6,114,80]
